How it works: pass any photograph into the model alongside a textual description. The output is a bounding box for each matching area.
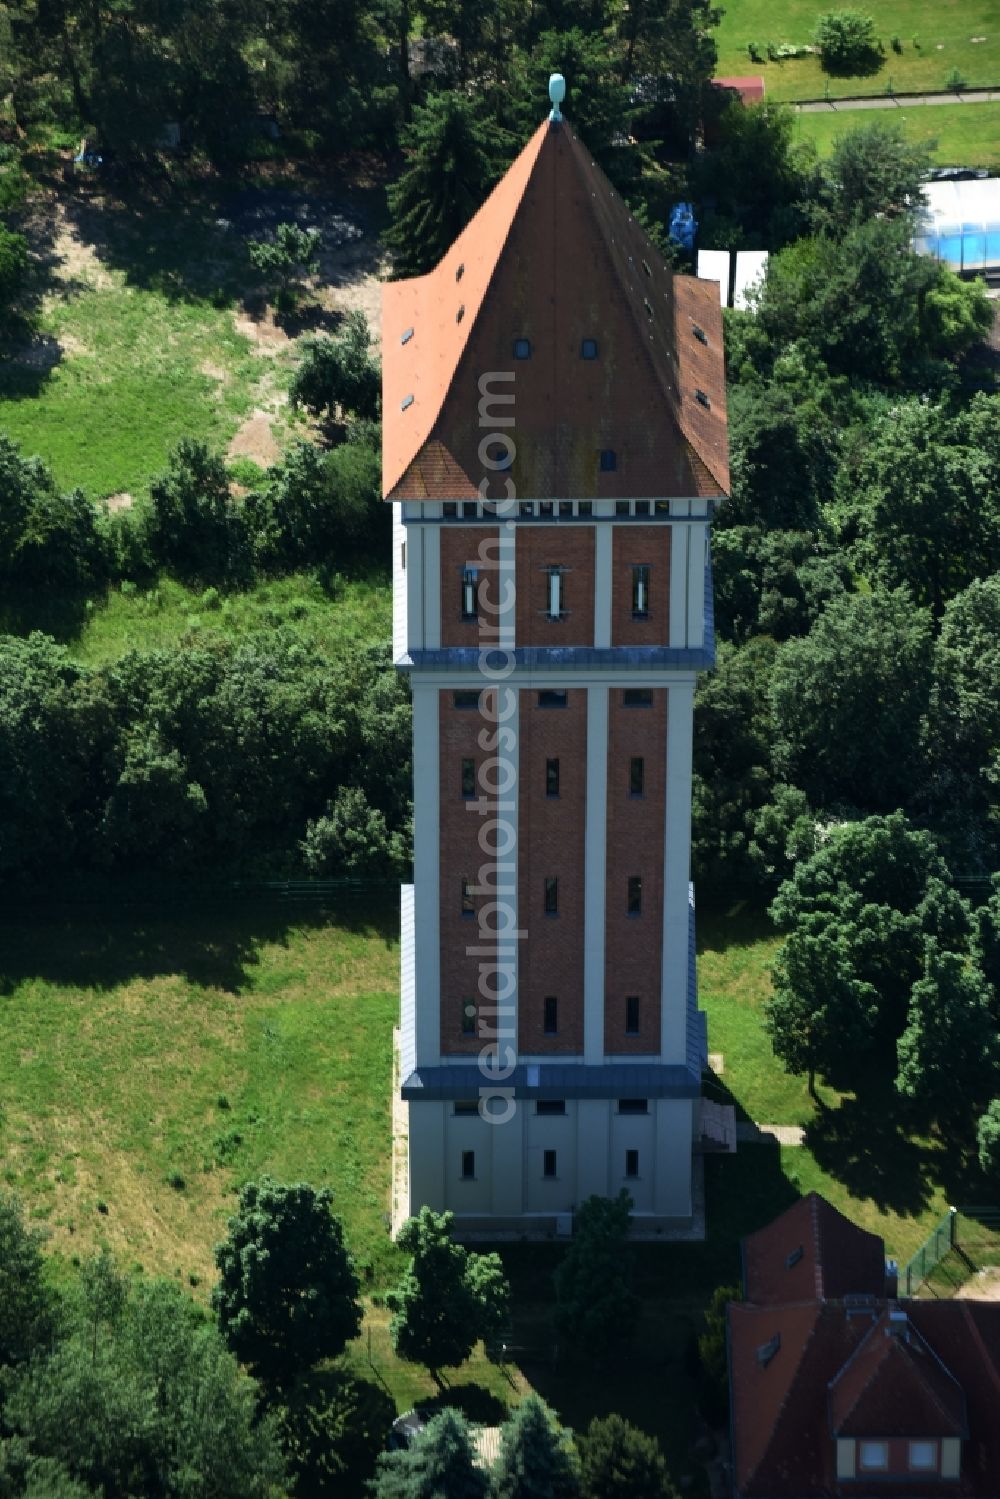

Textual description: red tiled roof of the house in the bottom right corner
[727,1198,1000,1499]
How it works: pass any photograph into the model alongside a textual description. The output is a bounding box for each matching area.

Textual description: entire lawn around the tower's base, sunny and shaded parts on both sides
[0,887,977,1475]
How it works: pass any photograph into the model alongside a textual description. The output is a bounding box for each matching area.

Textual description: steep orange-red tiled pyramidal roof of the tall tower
[382,121,729,499]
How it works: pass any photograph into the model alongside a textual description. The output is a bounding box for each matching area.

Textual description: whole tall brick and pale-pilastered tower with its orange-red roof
[382,105,729,1232]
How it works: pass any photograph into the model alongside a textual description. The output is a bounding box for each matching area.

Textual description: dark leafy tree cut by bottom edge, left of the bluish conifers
[280,1366,396,1499]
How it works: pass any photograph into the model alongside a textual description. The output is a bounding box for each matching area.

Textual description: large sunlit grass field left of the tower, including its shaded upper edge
[0,892,399,1285]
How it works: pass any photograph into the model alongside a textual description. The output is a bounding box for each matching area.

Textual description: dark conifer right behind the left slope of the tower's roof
[385,91,498,276]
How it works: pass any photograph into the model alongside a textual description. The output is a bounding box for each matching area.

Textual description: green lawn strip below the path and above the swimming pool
[795,102,1000,172]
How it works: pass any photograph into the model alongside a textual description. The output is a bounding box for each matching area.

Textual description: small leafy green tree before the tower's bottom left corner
[385,1207,510,1384]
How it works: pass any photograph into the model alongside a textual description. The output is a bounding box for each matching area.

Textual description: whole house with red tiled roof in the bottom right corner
[727,1192,1000,1499]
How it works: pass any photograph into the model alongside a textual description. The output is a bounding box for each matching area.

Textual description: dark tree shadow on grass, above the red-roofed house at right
[804,1090,943,1217]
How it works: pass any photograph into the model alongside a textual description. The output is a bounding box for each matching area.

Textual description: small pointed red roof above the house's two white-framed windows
[829,1309,967,1436]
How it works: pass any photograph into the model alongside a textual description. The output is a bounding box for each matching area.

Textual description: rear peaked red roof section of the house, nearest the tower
[744,1192,886,1304]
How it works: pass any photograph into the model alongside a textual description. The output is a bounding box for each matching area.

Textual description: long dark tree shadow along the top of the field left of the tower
[0,887,399,995]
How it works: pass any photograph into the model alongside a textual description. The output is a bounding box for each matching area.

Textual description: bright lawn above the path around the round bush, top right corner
[717,0,1000,99]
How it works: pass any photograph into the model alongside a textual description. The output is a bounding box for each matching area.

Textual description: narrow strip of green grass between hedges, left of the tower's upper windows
[66,573,393,666]
